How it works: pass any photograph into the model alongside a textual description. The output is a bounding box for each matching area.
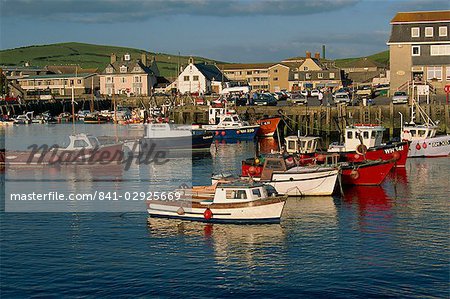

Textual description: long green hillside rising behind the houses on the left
[0,43,223,77]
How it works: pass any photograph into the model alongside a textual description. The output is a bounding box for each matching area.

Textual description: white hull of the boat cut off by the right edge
[408,135,450,158]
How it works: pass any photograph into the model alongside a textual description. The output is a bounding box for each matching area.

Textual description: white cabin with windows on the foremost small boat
[209,182,269,203]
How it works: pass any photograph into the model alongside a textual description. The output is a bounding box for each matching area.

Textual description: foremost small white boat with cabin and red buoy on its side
[147,182,286,224]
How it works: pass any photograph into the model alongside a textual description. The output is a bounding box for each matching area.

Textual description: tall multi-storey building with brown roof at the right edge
[387,10,450,94]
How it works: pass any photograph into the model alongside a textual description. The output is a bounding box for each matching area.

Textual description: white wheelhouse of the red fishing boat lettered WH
[328,124,385,152]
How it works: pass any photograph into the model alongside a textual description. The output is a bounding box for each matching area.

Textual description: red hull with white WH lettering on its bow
[340,141,409,167]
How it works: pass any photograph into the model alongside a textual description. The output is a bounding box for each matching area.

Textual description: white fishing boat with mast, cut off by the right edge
[400,100,450,157]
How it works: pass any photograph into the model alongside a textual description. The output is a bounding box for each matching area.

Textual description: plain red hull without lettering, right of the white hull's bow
[341,160,395,185]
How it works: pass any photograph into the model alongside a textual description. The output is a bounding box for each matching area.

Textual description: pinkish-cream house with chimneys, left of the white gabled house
[100,53,159,96]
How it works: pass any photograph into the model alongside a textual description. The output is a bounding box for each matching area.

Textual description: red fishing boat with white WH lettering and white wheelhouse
[328,124,409,167]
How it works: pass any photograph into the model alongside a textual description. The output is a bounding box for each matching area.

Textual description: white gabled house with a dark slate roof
[176,57,228,94]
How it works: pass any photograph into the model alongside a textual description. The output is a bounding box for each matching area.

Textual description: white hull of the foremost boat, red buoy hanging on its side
[147,197,286,224]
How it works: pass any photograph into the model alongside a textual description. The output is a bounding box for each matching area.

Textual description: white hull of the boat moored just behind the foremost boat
[254,168,339,196]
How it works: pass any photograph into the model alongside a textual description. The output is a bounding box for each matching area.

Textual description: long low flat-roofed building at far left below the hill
[17,73,99,97]
